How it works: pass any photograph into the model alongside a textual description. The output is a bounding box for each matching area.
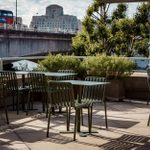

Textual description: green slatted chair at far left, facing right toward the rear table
[0,71,28,114]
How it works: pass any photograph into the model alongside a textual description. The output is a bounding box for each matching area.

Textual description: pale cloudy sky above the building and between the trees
[0,0,142,25]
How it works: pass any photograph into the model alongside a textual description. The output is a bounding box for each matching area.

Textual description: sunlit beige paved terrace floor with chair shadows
[0,100,150,150]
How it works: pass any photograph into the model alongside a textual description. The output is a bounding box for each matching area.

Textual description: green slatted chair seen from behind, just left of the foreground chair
[26,72,48,116]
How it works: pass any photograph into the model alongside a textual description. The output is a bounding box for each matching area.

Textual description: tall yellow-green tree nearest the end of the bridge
[72,0,110,55]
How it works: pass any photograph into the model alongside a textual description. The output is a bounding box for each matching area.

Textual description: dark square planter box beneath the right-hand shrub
[105,79,125,101]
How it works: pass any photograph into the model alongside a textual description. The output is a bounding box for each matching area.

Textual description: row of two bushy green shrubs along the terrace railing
[39,54,134,79]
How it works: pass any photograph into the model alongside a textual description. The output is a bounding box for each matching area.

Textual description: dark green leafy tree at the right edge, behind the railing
[111,3,150,56]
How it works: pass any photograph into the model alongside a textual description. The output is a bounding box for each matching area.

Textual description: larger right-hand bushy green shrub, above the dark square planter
[82,54,134,79]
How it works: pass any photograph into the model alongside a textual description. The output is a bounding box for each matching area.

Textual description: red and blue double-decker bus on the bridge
[0,9,14,29]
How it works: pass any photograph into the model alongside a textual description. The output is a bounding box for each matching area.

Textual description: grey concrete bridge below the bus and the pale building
[0,29,75,58]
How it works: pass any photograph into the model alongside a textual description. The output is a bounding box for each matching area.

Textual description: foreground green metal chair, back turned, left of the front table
[47,82,91,141]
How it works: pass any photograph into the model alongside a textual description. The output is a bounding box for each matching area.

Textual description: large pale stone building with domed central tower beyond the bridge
[30,5,79,33]
